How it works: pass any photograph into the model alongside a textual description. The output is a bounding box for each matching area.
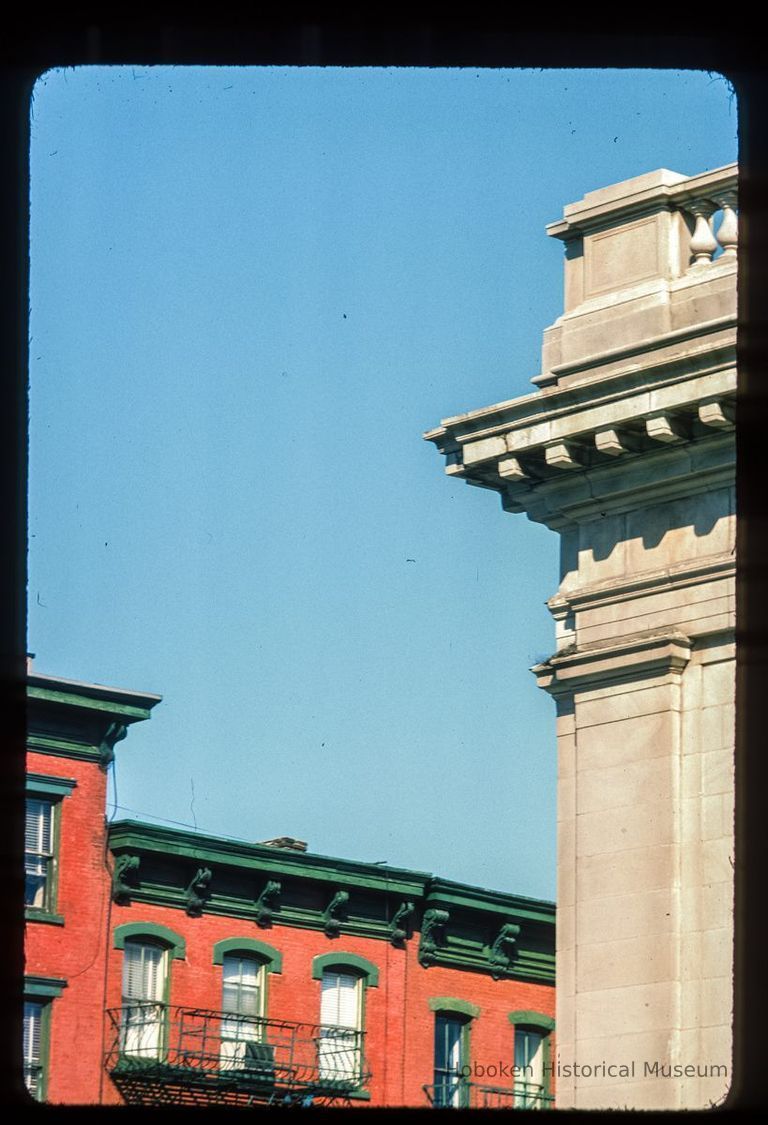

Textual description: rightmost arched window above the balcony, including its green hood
[313,953,379,1083]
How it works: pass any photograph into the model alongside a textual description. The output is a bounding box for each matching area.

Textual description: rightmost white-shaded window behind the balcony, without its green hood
[318,969,363,1081]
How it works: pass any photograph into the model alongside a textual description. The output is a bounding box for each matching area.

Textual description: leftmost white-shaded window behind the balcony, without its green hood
[120,939,168,1059]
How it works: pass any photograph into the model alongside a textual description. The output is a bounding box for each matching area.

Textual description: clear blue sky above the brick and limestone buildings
[28,66,737,898]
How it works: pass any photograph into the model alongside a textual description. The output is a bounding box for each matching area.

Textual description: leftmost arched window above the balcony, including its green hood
[115,923,184,1060]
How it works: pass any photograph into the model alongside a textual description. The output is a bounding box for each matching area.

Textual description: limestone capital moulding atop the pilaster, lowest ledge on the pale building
[531,631,692,696]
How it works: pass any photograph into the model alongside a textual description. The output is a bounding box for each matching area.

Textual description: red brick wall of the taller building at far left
[25,753,110,1103]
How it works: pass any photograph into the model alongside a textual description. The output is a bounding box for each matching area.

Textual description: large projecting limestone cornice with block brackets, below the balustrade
[425,355,737,529]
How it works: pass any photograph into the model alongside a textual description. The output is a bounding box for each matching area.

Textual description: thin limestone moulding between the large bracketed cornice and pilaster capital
[546,552,737,618]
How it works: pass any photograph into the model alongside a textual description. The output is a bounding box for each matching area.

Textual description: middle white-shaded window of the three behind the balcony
[220,953,265,1070]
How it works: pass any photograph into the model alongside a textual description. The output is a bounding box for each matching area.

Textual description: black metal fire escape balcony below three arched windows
[106,1001,370,1106]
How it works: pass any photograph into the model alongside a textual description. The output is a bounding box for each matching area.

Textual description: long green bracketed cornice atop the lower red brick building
[108,820,554,984]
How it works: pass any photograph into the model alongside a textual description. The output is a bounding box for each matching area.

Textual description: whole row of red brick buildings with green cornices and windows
[25,674,554,1108]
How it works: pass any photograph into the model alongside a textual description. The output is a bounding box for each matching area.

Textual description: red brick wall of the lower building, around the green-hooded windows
[105,903,554,1106]
